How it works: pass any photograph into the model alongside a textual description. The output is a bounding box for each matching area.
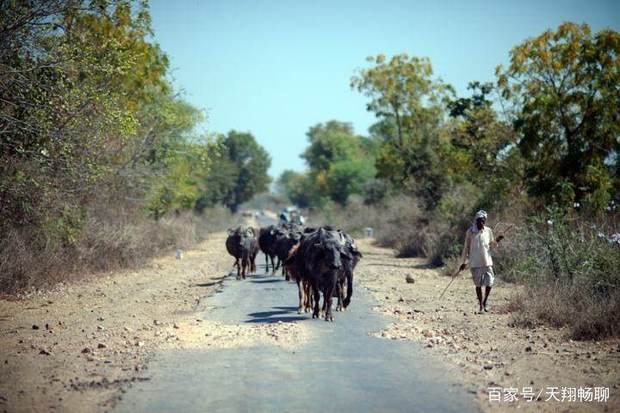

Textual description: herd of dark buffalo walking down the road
[226,225,362,321]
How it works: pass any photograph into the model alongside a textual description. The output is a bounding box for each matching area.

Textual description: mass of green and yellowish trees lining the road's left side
[0,0,269,292]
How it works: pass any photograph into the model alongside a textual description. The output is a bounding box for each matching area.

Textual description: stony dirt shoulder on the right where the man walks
[355,240,620,412]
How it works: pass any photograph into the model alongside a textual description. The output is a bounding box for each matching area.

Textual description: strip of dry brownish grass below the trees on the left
[0,204,232,294]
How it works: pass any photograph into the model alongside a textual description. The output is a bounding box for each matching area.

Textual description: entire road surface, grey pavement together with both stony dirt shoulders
[0,217,620,412]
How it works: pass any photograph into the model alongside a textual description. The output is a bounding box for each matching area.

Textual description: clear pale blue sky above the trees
[151,0,620,177]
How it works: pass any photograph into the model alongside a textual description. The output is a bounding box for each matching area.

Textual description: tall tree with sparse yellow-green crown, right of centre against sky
[351,54,452,209]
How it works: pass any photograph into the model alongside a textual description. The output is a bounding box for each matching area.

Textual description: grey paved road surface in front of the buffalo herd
[116,246,478,413]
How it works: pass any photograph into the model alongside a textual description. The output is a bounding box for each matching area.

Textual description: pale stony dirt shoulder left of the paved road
[0,233,235,412]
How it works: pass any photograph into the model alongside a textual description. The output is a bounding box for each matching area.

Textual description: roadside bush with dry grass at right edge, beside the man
[497,211,620,339]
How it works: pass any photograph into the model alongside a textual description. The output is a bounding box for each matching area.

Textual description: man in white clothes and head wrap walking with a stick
[459,210,504,313]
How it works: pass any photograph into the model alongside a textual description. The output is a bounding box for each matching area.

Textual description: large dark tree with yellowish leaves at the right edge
[497,23,620,210]
